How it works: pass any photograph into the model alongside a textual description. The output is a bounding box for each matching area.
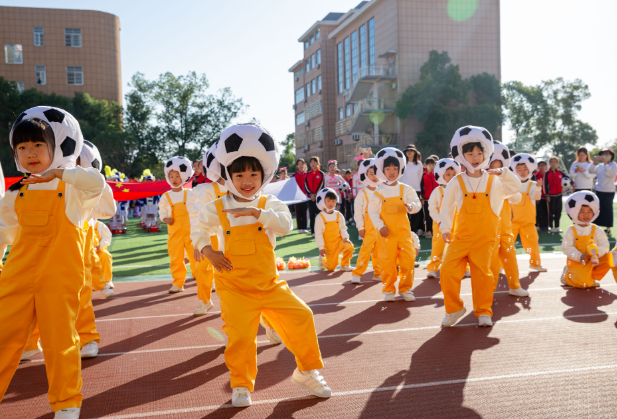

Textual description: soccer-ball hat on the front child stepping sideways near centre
[214,124,280,199]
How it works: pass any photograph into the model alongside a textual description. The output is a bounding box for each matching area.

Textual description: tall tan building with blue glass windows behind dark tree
[289,0,501,167]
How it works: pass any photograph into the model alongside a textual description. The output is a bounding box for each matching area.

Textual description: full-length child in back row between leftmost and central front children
[159,157,197,294]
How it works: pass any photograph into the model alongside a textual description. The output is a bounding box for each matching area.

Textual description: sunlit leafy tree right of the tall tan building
[503,77,598,167]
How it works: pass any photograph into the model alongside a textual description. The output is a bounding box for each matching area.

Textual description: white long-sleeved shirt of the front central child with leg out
[191,195,293,251]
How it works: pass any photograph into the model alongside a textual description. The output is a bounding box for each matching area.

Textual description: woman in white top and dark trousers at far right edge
[589,148,617,234]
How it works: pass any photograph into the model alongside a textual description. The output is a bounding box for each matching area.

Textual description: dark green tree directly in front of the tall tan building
[396,51,503,156]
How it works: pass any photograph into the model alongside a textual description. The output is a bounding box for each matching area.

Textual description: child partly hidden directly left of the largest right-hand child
[426,158,461,278]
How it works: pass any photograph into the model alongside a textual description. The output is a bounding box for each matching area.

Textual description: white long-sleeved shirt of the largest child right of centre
[439,169,521,233]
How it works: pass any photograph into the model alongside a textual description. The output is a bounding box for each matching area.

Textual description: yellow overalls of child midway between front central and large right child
[375,183,416,293]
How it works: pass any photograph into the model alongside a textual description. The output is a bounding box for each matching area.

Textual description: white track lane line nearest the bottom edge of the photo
[94,364,617,419]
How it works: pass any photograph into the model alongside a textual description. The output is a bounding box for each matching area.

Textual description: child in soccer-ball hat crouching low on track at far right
[561,191,610,288]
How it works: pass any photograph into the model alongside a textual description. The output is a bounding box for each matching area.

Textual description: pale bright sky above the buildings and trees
[0,0,617,149]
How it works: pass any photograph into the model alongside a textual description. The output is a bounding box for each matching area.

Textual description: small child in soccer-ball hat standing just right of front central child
[315,188,354,272]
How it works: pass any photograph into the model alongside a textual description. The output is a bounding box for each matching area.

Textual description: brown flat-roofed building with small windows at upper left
[0,6,122,104]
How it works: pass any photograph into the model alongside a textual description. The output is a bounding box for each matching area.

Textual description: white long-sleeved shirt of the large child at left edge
[0,166,104,246]
